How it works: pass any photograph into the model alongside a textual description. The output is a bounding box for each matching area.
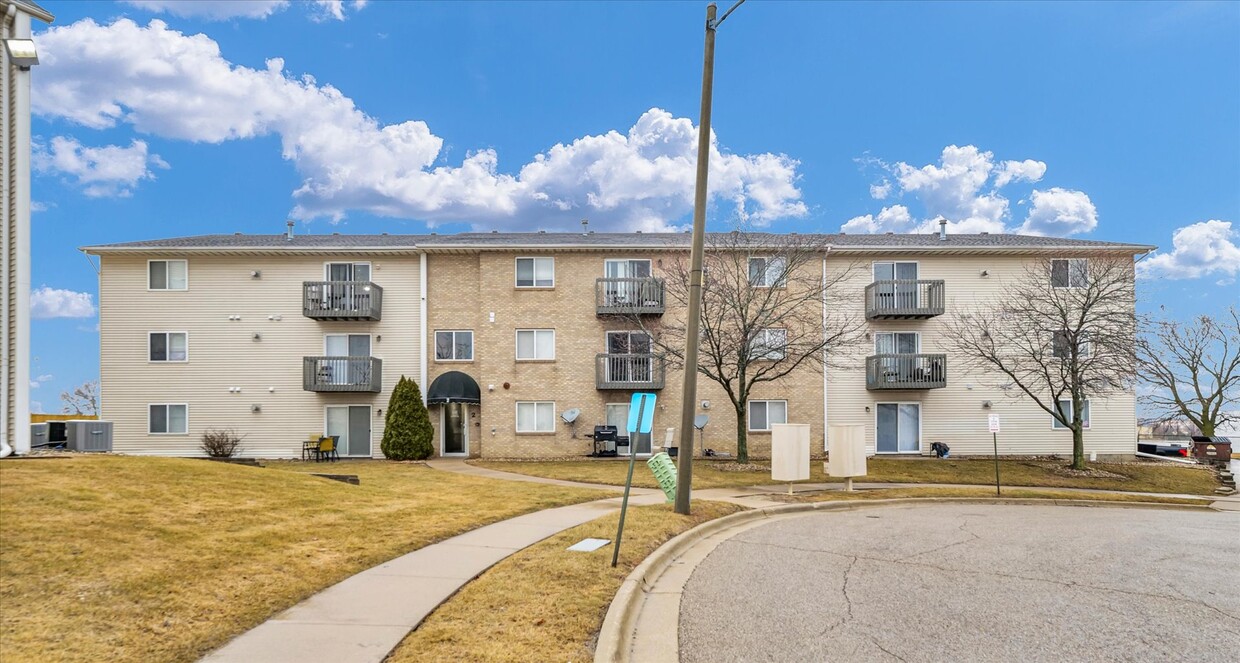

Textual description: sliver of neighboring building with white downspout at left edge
[0,0,52,455]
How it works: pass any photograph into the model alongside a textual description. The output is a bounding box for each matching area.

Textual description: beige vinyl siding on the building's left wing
[99,253,422,457]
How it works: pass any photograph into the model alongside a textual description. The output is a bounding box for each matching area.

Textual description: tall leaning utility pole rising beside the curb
[676,0,745,516]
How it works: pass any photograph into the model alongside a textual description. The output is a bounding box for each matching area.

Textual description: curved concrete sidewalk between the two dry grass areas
[203,490,665,663]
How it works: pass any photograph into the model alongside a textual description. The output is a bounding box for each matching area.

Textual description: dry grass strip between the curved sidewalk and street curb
[388,502,740,663]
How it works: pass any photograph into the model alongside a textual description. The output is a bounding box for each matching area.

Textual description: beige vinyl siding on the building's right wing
[827,254,1137,456]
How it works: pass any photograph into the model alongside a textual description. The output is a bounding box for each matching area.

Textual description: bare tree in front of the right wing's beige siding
[947,254,1136,470]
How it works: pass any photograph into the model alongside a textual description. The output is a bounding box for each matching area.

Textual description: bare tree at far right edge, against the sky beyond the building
[1137,306,1240,435]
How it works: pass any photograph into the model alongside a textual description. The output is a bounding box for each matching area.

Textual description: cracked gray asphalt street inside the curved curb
[680,504,1240,663]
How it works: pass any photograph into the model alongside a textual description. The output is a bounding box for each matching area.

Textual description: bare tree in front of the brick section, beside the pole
[627,231,864,462]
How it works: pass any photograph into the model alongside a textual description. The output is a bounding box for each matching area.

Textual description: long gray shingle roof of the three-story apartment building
[83,233,1154,253]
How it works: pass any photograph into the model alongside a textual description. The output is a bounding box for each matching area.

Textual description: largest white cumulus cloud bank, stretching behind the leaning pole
[33,19,808,229]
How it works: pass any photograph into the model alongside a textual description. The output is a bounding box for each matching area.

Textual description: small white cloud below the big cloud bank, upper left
[32,136,167,198]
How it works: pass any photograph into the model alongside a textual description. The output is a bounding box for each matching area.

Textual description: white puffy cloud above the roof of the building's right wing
[843,145,1097,235]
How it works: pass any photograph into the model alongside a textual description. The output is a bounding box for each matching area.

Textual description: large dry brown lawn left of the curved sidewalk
[0,456,602,663]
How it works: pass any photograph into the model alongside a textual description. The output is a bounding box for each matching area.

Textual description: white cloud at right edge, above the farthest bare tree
[1137,219,1240,278]
